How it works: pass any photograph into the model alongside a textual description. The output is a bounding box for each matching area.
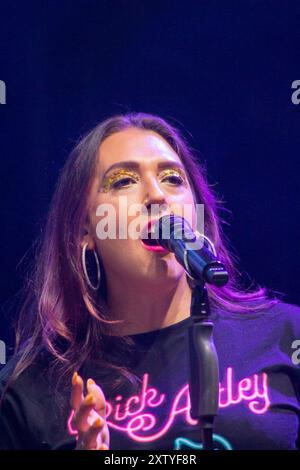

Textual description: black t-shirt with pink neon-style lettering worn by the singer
[0,302,300,450]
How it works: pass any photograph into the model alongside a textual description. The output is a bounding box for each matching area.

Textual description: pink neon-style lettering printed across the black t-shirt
[69,367,270,442]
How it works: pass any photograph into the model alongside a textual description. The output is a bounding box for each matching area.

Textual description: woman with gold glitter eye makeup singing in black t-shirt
[0,113,300,450]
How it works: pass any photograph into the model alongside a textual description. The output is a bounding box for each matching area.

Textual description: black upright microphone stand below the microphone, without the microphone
[187,278,219,450]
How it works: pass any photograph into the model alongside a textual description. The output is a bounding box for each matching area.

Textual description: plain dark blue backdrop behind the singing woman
[0,0,300,358]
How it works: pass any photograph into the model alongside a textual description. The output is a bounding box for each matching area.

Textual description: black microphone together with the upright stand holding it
[154,214,228,450]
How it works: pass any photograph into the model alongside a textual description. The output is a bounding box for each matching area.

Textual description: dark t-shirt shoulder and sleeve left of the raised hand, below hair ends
[0,355,69,449]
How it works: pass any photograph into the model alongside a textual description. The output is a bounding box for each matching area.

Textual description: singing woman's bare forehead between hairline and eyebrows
[98,129,180,172]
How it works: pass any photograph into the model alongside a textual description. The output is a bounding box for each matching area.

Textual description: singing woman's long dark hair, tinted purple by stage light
[3,113,278,396]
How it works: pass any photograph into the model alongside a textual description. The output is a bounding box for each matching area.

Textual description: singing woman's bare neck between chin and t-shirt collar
[108,273,191,336]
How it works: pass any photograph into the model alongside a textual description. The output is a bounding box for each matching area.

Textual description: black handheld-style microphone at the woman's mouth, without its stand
[152,214,228,287]
